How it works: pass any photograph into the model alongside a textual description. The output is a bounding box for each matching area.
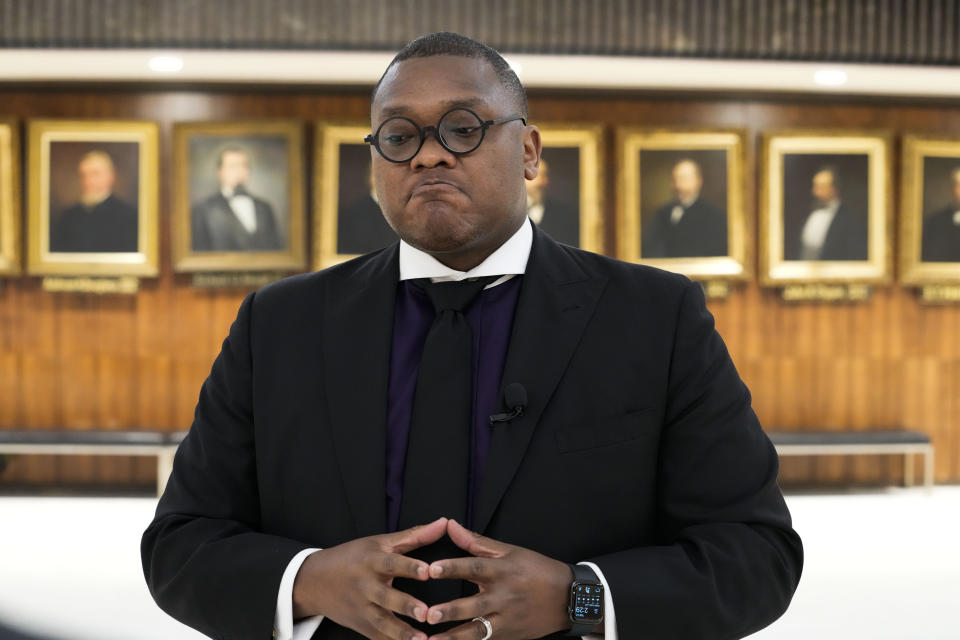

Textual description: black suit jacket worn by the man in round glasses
[142,231,802,640]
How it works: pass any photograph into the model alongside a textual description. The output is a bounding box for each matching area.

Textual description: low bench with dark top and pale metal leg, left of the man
[0,429,187,495]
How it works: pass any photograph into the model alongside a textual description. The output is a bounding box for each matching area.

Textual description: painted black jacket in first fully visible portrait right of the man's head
[640,198,727,258]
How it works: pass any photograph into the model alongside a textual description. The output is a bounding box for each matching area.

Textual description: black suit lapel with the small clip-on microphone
[473,228,606,532]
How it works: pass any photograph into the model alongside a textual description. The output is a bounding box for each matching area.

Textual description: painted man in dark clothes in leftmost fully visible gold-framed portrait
[50,151,138,253]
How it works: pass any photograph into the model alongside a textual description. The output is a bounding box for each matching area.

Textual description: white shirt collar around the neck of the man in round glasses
[400,220,533,286]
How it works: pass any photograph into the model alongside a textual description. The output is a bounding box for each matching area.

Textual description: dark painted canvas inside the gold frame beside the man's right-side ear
[527,148,580,247]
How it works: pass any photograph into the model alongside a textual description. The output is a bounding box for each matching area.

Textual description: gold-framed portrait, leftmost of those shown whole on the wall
[27,120,158,276]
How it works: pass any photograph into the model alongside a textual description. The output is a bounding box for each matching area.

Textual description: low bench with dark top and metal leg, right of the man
[767,430,933,487]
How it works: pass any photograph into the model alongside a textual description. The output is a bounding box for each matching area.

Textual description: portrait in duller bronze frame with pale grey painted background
[173,120,306,271]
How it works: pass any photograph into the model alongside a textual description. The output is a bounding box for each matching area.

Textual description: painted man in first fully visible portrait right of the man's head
[640,158,727,258]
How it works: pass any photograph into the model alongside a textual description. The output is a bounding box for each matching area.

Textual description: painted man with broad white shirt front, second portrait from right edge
[784,166,867,260]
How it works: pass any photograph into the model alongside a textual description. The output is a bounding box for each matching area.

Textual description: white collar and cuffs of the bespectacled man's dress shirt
[273,220,617,640]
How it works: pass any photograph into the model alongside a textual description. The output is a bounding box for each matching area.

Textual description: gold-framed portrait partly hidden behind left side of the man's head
[313,122,397,269]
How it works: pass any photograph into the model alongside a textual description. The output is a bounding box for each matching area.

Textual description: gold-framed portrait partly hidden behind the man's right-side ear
[527,122,603,253]
